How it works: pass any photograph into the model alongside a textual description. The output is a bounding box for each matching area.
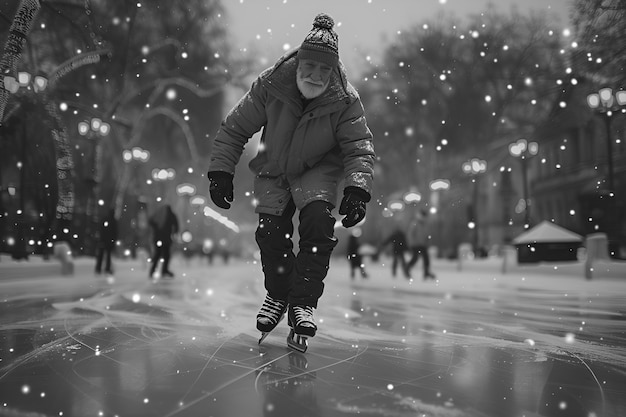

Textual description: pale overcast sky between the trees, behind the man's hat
[224,0,572,74]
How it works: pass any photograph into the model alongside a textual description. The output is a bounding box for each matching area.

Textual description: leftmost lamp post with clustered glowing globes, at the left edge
[2,71,48,259]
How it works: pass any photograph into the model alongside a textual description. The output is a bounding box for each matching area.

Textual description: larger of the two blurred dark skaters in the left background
[148,204,178,278]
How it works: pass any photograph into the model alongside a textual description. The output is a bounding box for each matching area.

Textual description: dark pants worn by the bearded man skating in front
[255,201,337,307]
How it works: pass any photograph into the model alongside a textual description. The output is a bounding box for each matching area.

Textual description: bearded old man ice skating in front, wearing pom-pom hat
[207,14,375,351]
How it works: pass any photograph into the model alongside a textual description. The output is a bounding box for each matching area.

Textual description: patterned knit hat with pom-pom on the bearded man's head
[298,13,339,67]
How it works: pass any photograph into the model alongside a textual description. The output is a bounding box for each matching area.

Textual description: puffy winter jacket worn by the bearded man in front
[209,49,375,215]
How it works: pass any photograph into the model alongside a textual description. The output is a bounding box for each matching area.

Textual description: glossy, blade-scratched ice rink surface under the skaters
[0,256,626,417]
